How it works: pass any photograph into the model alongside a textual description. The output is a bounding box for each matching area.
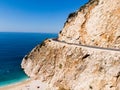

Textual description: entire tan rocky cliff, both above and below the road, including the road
[21,0,120,90]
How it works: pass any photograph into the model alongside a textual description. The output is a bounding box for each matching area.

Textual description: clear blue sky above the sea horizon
[0,0,88,33]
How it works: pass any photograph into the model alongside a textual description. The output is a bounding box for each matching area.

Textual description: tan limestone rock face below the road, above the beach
[22,40,120,90]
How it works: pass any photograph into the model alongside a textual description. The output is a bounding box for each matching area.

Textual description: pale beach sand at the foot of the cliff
[0,80,51,90]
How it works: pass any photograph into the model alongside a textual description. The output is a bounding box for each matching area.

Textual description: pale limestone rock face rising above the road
[59,0,120,48]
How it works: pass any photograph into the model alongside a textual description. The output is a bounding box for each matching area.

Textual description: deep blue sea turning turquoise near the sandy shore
[0,32,57,86]
